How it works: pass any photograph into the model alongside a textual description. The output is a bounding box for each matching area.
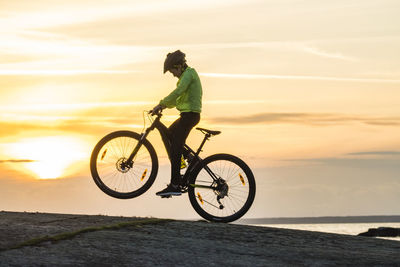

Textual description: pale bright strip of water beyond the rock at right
[254,223,400,241]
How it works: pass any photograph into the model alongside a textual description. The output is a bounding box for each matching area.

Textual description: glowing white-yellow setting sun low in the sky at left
[10,136,88,179]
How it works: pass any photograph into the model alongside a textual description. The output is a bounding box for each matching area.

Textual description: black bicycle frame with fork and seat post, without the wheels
[126,113,218,189]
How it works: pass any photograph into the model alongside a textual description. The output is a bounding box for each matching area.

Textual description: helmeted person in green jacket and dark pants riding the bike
[151,50,203,197]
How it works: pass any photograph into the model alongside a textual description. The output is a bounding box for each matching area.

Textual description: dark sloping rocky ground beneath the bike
[0,212,400,266]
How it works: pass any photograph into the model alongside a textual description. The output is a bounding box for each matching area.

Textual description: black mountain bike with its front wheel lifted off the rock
[90,112,256,222]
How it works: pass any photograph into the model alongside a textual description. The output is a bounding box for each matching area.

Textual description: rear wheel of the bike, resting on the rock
[188,154,256,222]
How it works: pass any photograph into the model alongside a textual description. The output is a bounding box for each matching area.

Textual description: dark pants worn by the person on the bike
[168,112,200,184]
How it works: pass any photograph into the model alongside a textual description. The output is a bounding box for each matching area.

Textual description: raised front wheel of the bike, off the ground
[90,131,158,199]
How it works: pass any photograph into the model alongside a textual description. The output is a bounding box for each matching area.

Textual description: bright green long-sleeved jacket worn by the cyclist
[160,67,203,113]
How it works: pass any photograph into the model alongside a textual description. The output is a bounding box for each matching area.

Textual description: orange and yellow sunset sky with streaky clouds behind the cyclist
[0,0,400,219]
